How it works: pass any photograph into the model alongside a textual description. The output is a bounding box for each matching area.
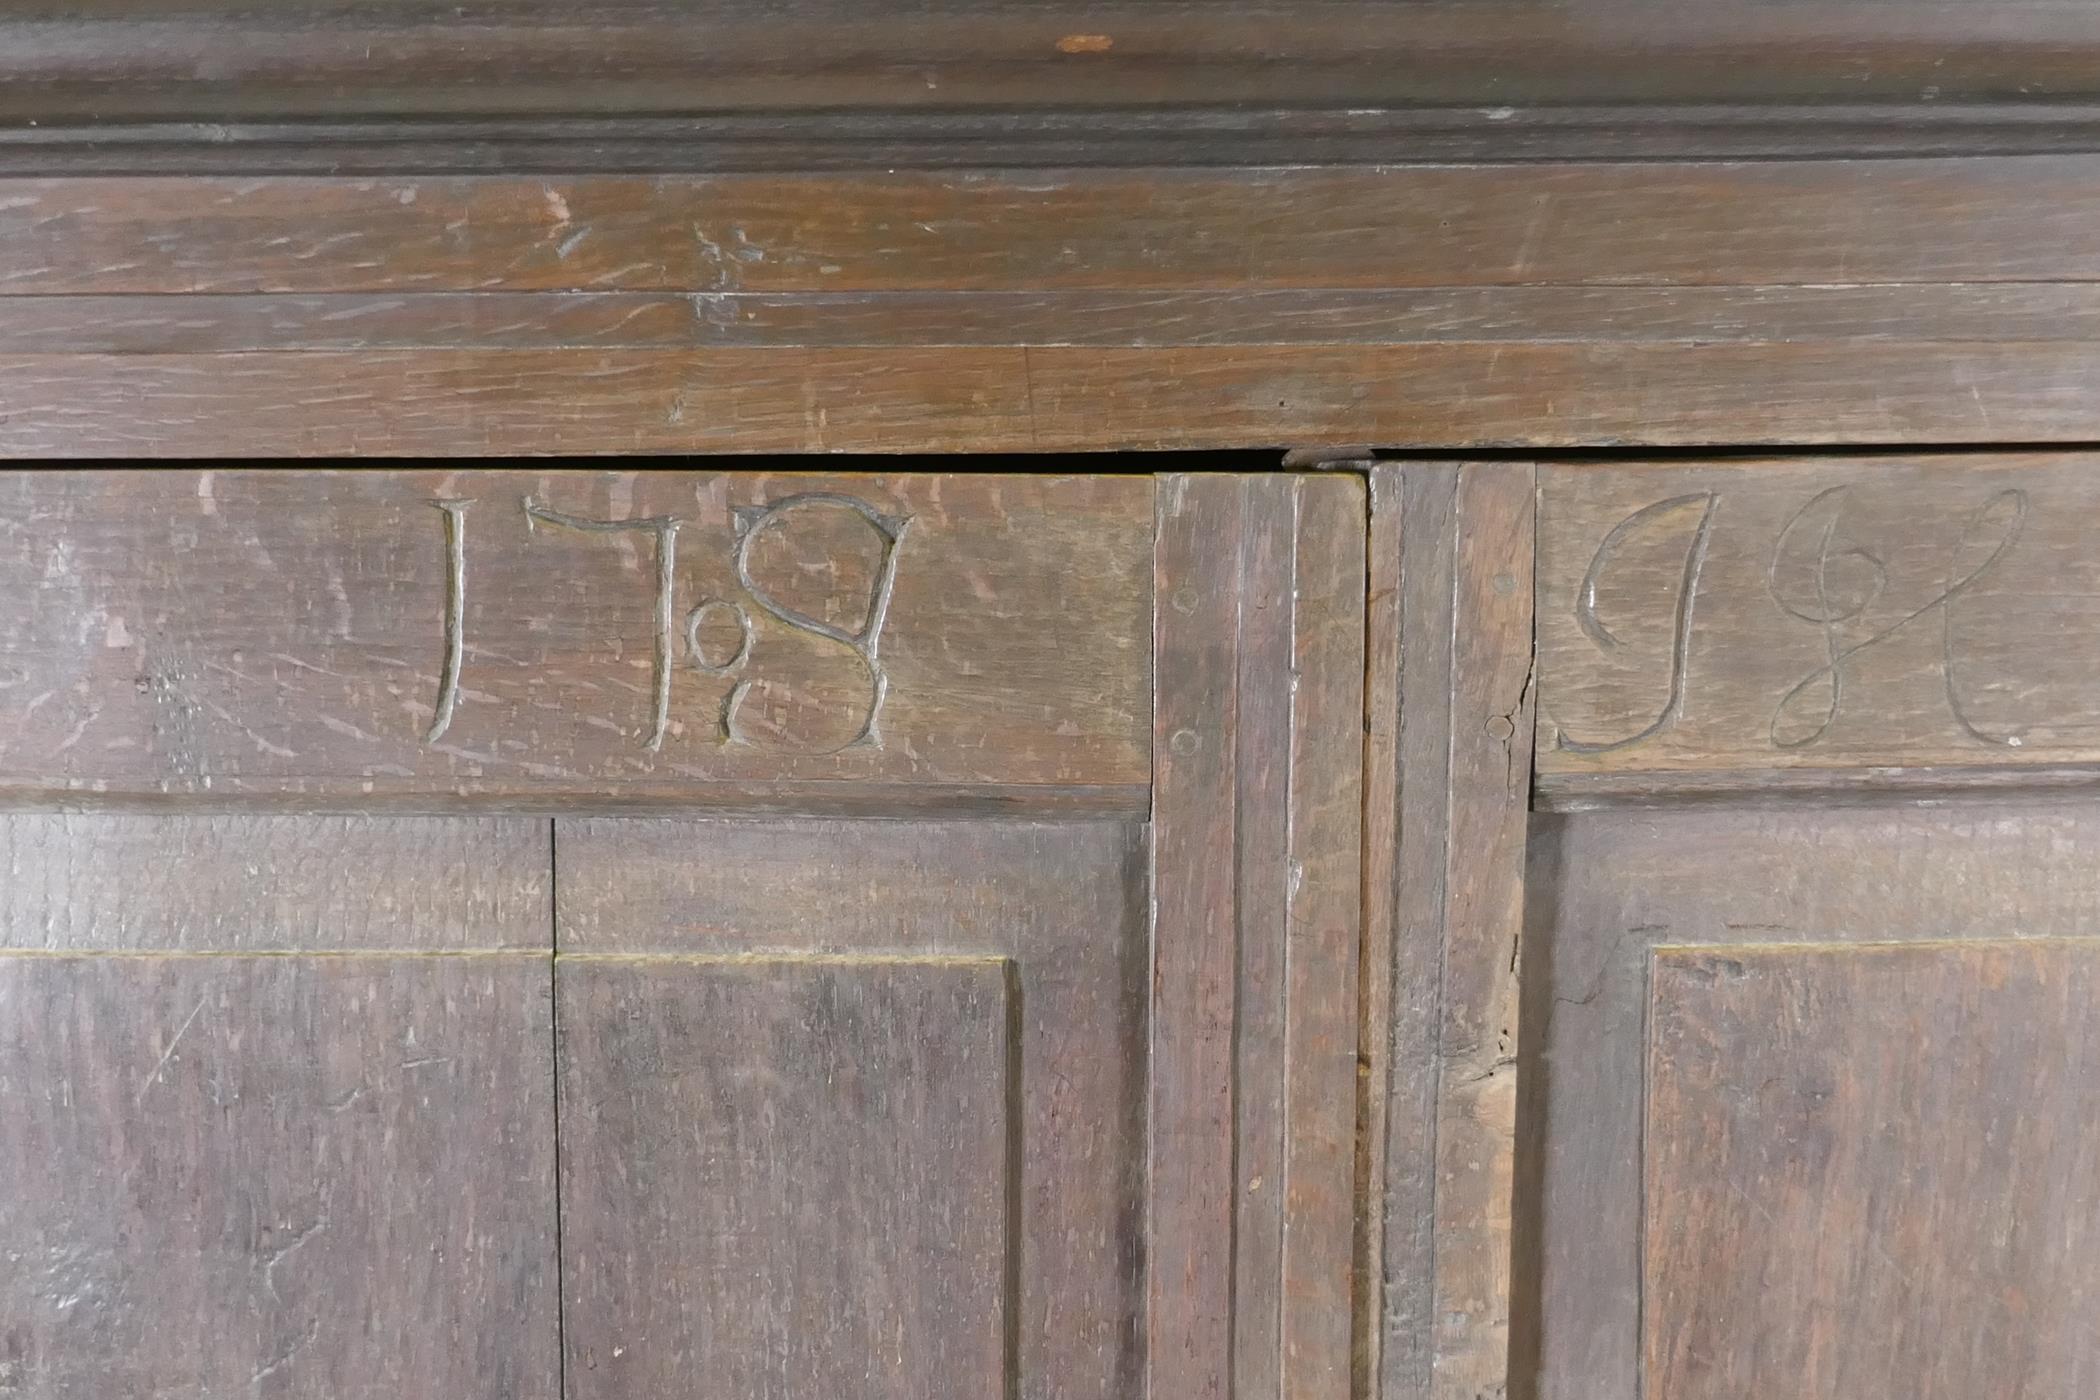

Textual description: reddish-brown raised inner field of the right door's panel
[1642,928,2100,1400]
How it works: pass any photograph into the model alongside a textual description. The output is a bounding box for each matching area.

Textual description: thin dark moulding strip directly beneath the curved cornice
[12,99,2100,178]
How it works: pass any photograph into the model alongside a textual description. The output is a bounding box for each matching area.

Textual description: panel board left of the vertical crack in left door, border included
[0,814,561,1400]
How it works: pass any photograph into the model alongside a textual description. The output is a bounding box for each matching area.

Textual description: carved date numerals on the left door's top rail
[424,491,911,751]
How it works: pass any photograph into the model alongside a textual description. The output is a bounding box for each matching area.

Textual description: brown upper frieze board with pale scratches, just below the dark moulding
[0,155,2100,296]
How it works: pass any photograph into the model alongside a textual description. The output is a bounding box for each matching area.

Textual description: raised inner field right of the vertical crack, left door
[559,955,1021,1400]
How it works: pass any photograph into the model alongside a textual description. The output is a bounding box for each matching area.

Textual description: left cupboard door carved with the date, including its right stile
[0,468,1367,1400]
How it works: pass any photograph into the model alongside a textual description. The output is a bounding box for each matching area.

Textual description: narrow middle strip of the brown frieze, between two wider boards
[20,279,2100,363]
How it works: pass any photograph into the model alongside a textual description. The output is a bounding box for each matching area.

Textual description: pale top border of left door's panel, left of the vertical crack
[0,812,552,953]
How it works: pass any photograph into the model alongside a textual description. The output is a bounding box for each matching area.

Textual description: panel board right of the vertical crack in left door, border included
[557,819,1149,1400]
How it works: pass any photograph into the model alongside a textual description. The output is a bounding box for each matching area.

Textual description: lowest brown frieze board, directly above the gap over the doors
[0,336,2100,460]
